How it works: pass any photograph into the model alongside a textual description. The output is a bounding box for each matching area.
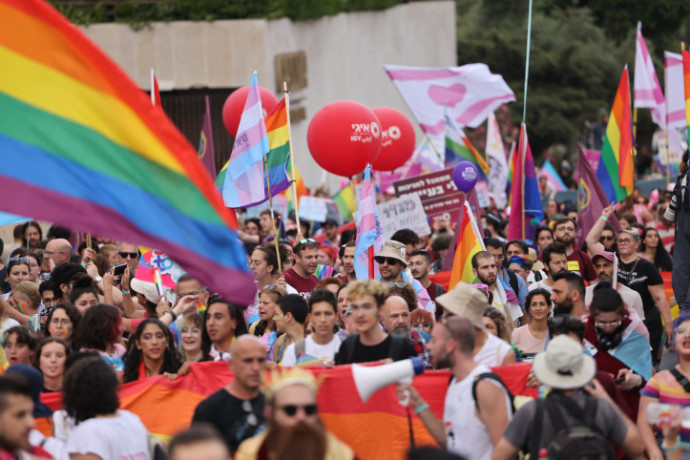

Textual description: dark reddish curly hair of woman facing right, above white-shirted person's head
[74,304,122,351]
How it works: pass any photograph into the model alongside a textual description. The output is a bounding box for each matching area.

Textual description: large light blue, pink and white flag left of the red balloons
[223,71,270,208]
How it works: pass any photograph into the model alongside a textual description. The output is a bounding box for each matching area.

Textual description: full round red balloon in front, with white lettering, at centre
[307,101,381,177]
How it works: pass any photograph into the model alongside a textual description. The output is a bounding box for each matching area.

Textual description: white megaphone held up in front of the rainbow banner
[352,358,424,402]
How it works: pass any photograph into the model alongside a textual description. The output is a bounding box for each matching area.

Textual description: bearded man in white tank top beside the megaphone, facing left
[398,316,512,460]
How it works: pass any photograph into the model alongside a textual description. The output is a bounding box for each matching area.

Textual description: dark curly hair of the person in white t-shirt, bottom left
[62,356,120,424]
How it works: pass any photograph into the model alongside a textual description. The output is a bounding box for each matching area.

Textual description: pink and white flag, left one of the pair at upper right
[634,22,666,129]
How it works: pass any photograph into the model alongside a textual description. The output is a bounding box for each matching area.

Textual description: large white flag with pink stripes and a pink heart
[383,64,515,151]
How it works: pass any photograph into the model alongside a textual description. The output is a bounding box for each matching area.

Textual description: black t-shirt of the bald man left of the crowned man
[192,388,266,453]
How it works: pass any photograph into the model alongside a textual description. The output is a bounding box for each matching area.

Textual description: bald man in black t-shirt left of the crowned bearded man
[192,334,266,454]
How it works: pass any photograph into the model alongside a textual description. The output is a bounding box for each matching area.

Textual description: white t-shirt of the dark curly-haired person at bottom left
[65,410,150,460]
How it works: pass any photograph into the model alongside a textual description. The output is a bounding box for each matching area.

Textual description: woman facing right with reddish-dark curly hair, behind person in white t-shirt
[75,305,126,373]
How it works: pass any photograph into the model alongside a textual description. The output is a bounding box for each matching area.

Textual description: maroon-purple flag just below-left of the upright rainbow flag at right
[577,146,619,248]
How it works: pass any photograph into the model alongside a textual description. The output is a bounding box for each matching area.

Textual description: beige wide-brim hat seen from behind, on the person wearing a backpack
[532,334,597,390]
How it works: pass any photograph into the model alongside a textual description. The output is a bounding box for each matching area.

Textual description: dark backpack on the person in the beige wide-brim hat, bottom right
[530,393,616,460]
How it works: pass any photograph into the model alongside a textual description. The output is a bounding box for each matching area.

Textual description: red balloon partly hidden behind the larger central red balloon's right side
[371,107,415,171]
